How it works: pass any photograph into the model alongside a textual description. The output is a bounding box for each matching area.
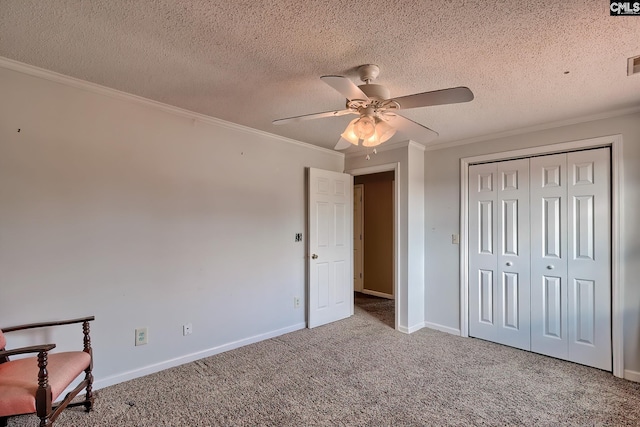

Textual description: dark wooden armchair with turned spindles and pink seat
[0,316,94,427]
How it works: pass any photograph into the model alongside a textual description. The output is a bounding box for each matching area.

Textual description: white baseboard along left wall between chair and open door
[90,323,307,396]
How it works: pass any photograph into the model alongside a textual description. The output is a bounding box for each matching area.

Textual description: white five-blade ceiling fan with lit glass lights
[273,64,473,150]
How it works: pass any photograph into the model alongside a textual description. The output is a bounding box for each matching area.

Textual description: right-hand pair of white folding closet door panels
[530,148,612,371]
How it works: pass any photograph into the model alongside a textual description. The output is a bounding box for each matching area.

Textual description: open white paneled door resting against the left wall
[308,168,353,328]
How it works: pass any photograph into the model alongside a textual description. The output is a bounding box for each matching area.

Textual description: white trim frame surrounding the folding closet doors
[460,134,624,378]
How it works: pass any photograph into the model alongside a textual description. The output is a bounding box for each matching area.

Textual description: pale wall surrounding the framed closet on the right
[425,113,640,381]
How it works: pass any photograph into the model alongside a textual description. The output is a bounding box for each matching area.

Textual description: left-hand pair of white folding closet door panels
[469,159,530,350]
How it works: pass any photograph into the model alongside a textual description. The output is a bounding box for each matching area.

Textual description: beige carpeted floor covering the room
[9,296,640,427]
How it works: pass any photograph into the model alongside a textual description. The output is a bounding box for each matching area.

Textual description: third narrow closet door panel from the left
[530,154,568,359]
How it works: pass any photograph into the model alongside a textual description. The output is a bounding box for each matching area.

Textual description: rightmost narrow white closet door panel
[567,148,612,371]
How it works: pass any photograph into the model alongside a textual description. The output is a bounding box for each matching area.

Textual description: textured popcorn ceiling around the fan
[0,0,640,152]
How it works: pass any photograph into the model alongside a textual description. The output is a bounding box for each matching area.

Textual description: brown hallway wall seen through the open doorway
[354,172,393,295]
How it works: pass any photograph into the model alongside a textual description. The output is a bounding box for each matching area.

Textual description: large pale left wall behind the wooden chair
[0,64,344,388]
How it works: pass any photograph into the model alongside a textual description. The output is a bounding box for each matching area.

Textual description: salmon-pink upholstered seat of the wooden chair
[0,351,91,417]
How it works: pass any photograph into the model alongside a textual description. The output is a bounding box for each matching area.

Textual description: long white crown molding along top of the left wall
[0,56,345,158]
